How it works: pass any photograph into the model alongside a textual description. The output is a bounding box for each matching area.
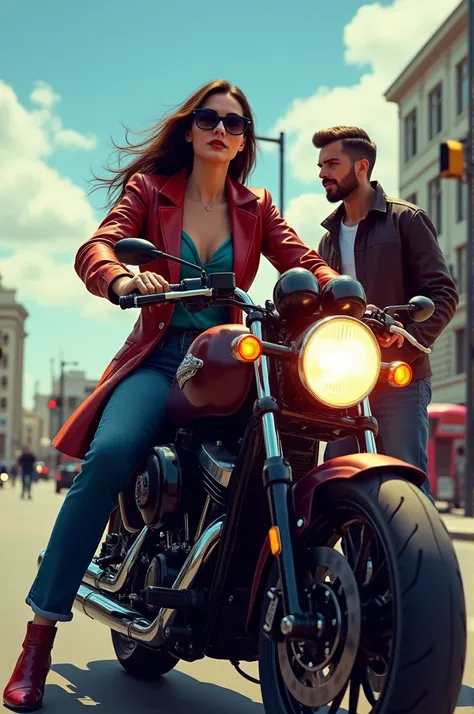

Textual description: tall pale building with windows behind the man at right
[385,2,469,404]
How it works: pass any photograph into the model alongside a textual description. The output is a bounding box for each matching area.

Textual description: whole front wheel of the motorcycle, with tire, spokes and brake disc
[259,475,466,714]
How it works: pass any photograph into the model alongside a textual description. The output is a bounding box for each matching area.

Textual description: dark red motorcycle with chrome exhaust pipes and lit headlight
[40,238,466,714]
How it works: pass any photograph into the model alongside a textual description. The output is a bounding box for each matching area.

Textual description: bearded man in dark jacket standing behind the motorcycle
[313,126,458,473]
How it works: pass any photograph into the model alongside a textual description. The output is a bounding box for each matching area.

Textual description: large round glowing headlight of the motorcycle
[298,317,381,409]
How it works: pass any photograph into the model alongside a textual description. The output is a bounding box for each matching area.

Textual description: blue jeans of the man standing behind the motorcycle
[324,377,431,493]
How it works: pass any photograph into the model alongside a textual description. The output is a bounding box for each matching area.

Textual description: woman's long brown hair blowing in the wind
[91,79,256,208]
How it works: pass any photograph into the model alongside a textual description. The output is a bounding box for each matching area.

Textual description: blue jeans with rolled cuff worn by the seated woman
[26,329,197,622]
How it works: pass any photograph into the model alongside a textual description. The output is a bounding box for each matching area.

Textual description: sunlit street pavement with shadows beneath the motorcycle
[0,482,474,714]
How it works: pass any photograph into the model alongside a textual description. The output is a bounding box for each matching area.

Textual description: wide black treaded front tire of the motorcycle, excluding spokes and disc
[259,475,466,714]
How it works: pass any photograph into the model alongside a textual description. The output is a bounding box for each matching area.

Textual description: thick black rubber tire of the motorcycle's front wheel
[259,475,466,714]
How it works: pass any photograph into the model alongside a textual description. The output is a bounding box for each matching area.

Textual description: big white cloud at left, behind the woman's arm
[0,81,113,316]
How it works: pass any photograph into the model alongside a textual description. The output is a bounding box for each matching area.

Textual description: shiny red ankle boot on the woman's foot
[3,622,56,712]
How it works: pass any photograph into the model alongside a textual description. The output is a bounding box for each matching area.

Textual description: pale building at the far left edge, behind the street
[0,277,28,462]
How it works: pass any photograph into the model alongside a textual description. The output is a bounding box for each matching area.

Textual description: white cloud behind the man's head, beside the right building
[276,0,458,221]
